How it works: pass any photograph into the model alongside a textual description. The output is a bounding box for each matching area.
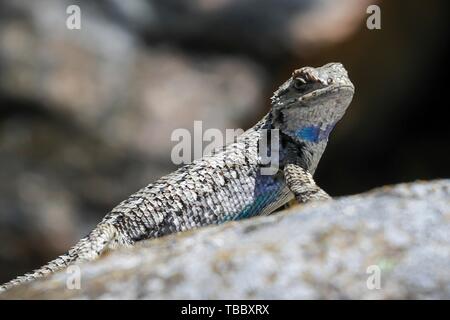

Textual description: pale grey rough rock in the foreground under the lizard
[1,179,450,299]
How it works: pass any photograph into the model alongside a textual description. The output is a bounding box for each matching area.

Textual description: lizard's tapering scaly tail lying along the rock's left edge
[0,223,117,293]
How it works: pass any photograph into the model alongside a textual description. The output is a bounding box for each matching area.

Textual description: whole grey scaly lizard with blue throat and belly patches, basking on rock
[0,63,354,292]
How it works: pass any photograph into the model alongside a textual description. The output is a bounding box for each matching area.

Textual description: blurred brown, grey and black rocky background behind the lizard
[0,0,450,282]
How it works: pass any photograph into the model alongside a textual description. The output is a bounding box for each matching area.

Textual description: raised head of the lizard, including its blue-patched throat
[272,63,355,143]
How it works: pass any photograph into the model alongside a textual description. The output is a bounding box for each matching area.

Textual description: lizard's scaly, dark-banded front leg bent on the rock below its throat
[284,163,331,203]
